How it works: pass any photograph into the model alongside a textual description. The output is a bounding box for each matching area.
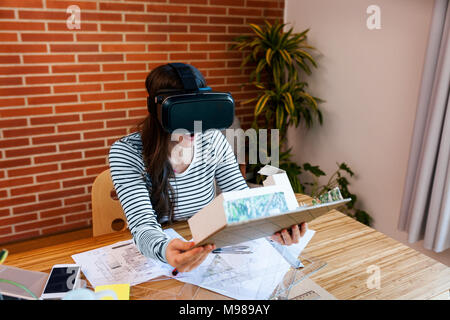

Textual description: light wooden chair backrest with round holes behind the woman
[91,169,127,237]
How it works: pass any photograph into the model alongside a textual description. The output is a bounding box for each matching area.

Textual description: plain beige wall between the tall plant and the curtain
[285,0,450,265]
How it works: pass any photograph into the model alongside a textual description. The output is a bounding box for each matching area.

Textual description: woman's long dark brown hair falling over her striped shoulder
[138,65,206,223]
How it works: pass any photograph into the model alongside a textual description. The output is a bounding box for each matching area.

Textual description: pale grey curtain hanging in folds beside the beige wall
[398,0,450,252]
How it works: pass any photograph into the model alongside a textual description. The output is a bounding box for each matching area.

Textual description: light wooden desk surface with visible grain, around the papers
[5,195,450,300]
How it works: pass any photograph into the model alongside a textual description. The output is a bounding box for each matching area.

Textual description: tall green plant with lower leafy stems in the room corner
[230,21,372,225]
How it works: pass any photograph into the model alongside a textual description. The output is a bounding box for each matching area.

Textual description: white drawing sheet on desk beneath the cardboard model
[176,230,315,300]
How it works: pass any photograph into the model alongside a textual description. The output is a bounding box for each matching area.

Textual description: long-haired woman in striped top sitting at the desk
[109,65,306,272]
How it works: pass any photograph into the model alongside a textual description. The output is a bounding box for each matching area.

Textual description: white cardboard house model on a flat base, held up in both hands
[188,166,350,248]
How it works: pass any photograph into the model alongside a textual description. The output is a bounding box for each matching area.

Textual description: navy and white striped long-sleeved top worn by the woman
[109,130,248,262]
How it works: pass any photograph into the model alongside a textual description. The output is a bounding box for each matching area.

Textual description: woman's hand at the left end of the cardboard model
[166,239,216,272]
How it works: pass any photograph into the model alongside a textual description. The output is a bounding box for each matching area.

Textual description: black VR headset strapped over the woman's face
[147,63,234,134]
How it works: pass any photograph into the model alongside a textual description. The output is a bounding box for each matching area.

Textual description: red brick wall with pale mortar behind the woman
[0,0,284,243]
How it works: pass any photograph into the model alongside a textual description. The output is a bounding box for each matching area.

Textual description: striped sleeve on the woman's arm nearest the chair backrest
[109,140,170,262]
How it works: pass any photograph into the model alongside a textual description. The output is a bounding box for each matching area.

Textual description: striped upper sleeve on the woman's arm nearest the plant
[212,131,249,192]
